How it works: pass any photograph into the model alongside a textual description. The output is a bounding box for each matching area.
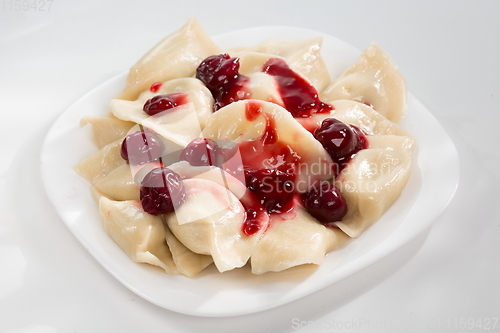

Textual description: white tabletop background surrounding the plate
[0,0,500,333]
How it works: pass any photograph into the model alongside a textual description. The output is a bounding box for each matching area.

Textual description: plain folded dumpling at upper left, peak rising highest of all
[117,19,220,100]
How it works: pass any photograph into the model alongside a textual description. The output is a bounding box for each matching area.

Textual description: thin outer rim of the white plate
[40,26,460,317]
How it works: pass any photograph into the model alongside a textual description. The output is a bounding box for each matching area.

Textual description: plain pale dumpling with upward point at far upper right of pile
[320,43,406,123]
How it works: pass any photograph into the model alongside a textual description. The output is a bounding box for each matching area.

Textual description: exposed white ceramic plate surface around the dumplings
[41,27,459,316]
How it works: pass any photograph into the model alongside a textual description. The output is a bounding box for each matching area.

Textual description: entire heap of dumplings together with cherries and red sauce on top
[75,20,415,277]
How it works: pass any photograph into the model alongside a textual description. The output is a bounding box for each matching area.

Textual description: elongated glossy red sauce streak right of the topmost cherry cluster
[262,58,333,118]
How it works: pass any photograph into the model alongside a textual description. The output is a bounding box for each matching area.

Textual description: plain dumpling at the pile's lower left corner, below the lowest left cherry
[99,197,179,274]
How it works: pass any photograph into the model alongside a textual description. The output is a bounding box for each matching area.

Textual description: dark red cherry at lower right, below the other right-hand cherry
[302,183,347,223]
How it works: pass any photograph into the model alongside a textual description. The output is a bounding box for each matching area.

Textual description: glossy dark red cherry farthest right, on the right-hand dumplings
[314,118,358,159]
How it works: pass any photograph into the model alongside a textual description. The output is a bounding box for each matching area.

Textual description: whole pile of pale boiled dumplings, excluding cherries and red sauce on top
[75,20,415,277]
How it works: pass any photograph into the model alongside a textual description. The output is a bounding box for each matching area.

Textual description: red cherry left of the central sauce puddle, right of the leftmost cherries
[180,138,218,166]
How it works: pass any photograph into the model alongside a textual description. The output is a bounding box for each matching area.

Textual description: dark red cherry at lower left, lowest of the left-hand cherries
[140,167,186,215]
